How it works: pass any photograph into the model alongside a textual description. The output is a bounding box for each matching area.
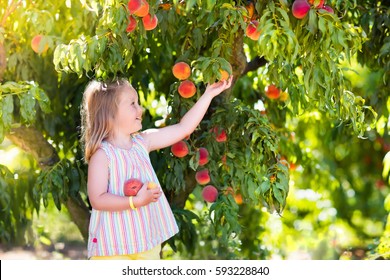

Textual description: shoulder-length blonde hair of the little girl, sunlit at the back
[81,79,133,163]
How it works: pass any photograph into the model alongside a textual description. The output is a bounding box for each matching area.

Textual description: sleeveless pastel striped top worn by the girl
[88,134,178,257]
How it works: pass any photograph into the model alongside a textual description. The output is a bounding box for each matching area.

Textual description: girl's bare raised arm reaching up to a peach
[143,76,233,151]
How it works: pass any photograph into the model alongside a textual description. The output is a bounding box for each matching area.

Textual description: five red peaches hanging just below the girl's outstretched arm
[171,127,227,202]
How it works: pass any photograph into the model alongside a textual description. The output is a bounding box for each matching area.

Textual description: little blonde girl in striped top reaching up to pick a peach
[81,75,232,259]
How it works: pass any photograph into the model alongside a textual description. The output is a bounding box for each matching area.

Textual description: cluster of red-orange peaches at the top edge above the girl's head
[126,0,158,33]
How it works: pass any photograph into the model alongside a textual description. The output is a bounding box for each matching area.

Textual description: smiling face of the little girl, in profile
[114,86,142,134]
